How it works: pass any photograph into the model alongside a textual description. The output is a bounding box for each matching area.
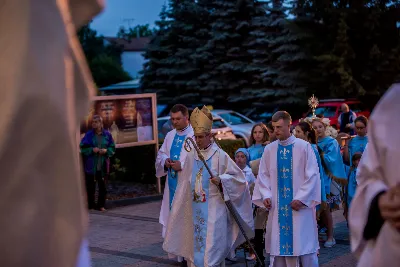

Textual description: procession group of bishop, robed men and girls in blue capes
[155,104,368,267]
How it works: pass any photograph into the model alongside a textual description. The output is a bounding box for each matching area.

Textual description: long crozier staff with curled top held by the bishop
[184,137,263,266]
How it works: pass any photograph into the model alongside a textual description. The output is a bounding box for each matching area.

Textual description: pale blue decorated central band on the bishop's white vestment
[191,157,212,266]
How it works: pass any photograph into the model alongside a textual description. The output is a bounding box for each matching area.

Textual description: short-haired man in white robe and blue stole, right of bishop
[253,111,321,267]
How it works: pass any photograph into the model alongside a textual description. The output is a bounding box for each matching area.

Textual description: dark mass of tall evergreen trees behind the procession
[141,0,400,108]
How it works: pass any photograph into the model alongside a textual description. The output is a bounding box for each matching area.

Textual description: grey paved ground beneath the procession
[89,202,356,267]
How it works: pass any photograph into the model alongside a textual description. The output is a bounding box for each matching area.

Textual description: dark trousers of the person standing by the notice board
[85,171,107,209]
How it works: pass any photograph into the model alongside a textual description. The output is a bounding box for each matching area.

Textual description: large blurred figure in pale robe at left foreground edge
[0,0,102,267]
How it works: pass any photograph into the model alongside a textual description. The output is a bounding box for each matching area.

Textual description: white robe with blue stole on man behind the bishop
[156,125,194,237]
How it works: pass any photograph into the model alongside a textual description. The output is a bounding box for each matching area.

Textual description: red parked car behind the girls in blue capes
[293,99,371,129]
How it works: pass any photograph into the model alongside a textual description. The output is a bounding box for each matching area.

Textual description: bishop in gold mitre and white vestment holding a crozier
[163,107,254,267]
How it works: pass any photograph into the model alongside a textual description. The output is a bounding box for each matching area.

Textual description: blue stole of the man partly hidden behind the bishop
[168,134,186,209]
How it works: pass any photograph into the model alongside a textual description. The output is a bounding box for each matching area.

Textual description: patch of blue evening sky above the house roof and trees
[91,0,166,36]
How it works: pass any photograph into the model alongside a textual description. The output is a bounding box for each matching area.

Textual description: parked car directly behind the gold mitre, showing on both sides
[157,115,236,142]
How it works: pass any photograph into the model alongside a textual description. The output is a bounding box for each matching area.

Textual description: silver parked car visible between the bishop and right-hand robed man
[211,109,255,146]
